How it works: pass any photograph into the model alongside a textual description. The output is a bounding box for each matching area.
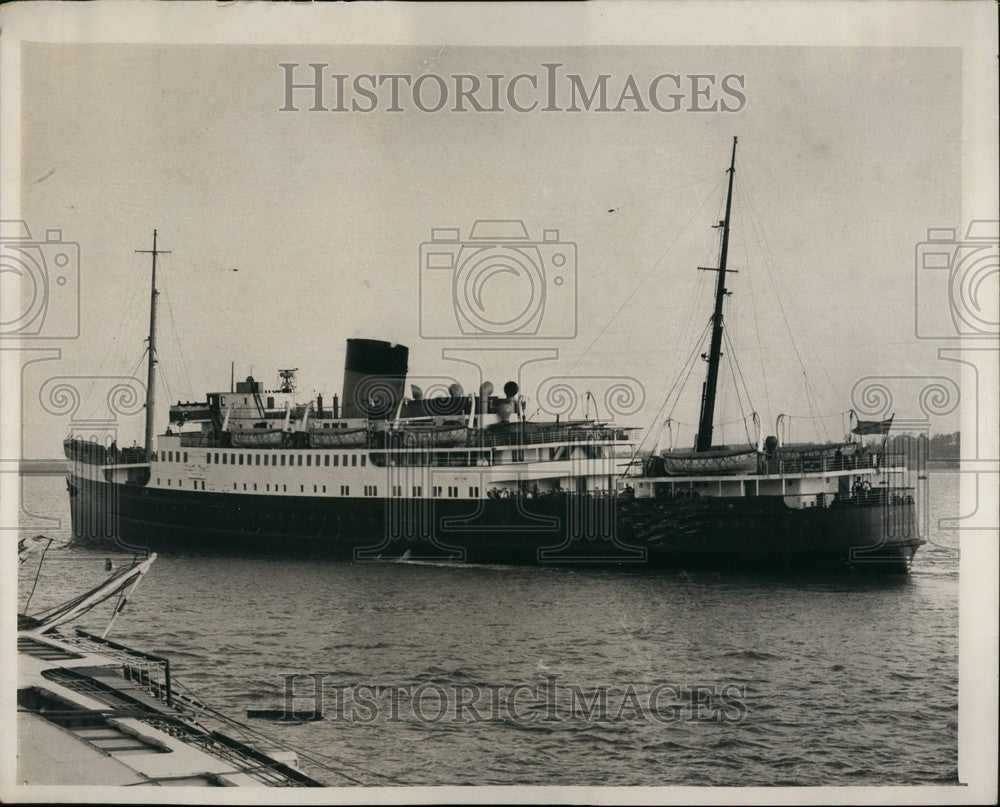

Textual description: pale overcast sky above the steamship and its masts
[21,44,963,456]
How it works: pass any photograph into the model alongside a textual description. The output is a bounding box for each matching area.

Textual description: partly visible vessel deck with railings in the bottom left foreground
[17,536,330,787]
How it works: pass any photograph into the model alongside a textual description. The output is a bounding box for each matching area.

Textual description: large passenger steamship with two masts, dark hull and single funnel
[64,144,924,573]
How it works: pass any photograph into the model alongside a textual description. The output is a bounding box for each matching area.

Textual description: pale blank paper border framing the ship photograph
[0,0,1000,804]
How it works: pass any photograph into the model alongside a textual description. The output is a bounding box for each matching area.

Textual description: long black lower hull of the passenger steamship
[68,476,923,573]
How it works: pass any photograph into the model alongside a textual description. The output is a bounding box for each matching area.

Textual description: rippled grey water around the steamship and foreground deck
[20,472,958,785]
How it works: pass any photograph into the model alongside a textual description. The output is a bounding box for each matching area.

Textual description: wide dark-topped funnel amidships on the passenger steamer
[341,339,410,420]
